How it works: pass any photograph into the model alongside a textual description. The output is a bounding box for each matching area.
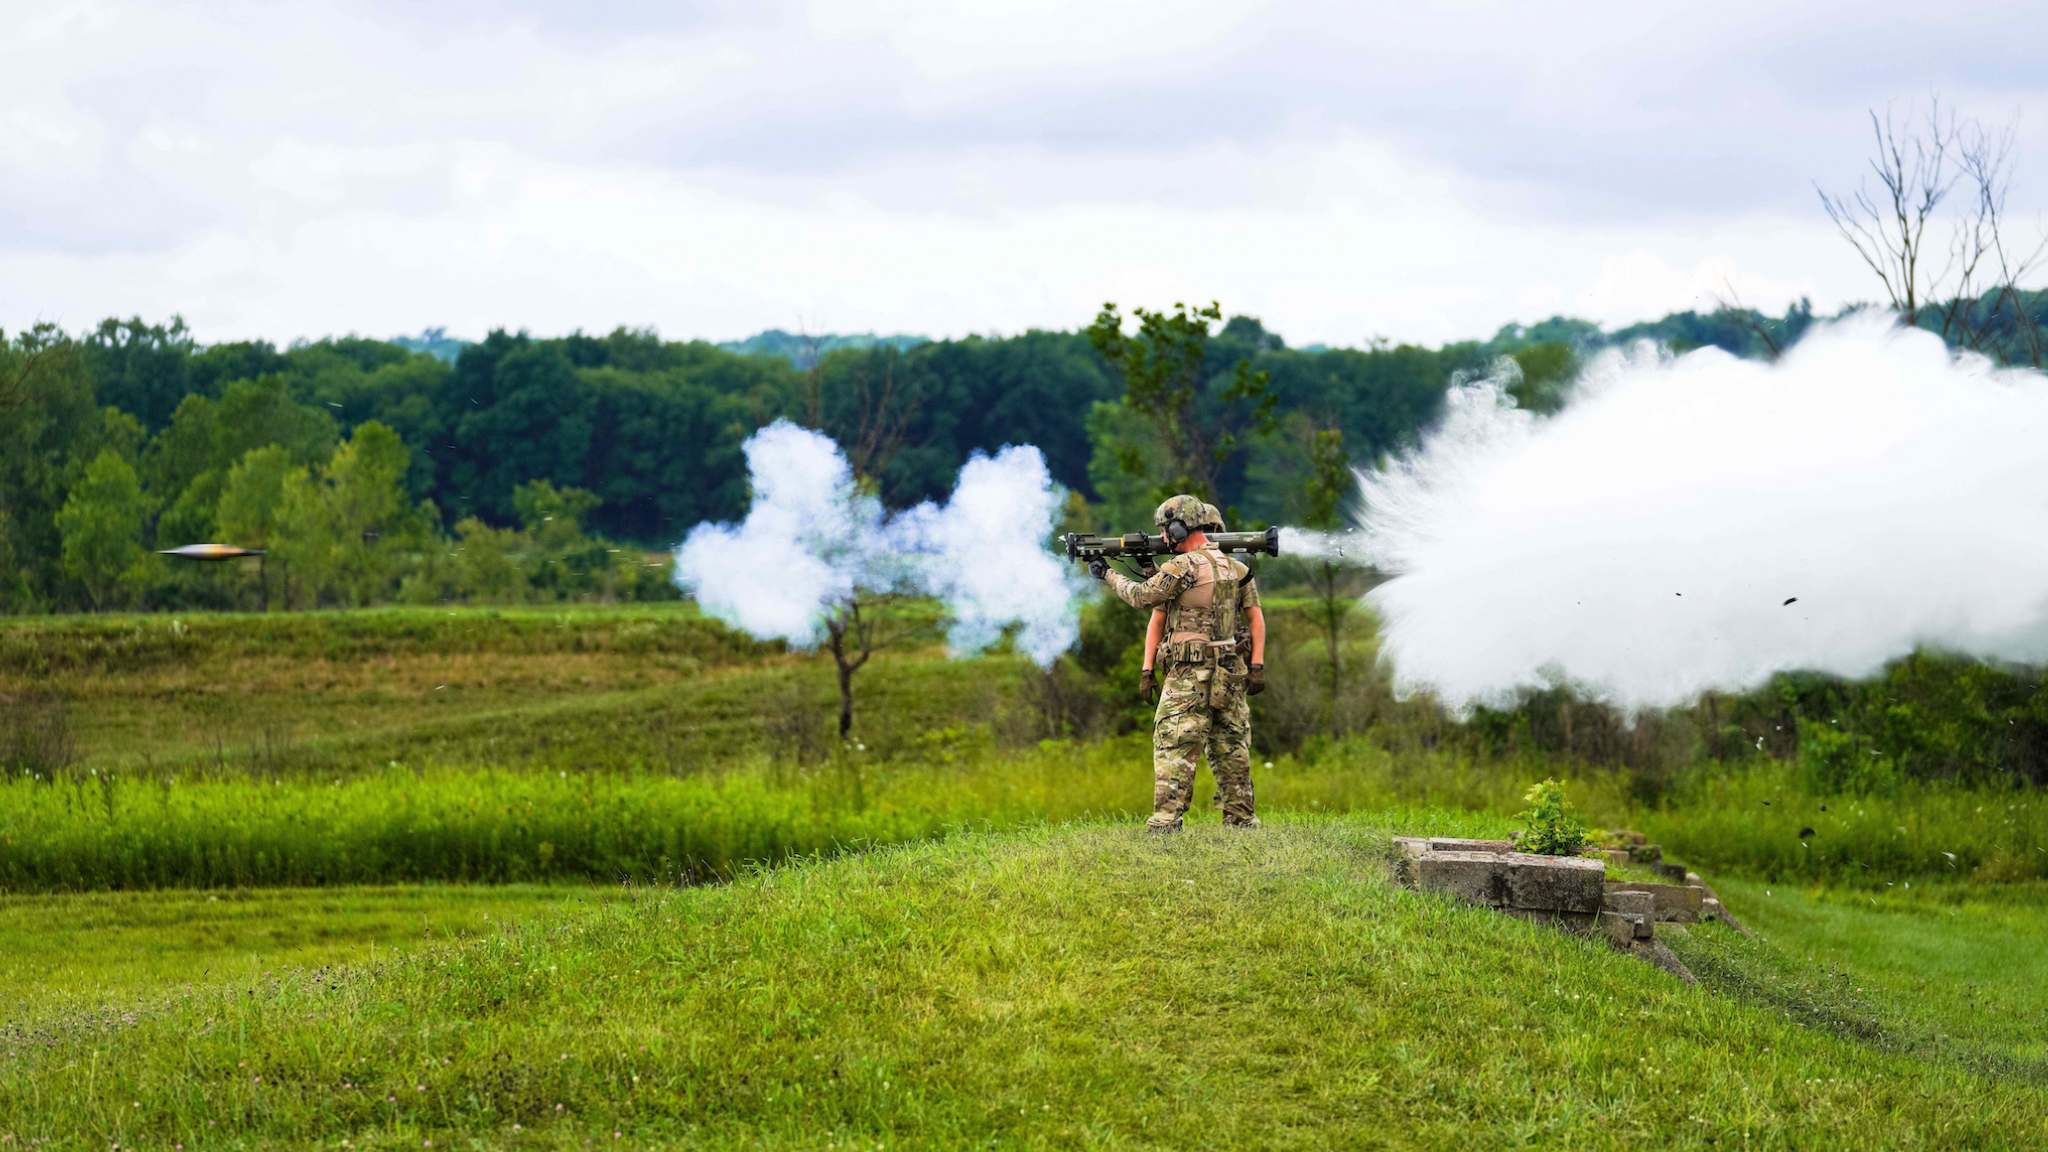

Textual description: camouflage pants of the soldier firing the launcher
[1145,664,1255,828]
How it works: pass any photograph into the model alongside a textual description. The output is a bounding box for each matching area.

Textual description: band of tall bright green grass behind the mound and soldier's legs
[0,728,1540,892]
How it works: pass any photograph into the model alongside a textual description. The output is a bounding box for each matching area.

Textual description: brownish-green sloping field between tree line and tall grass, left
[0,605,970,775]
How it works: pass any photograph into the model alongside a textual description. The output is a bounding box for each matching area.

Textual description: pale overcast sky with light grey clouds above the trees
[0,0,2048,344]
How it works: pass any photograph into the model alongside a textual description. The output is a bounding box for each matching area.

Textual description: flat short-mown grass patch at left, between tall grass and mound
[0,883,625,1019]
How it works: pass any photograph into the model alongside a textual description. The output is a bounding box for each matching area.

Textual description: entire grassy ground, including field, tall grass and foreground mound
[0,605,2048,1152]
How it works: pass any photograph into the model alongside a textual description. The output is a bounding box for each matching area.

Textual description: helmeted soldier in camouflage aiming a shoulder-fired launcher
[1087,496,1266,832]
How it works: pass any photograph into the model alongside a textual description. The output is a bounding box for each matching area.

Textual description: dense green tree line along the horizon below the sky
[0,291,1998,613]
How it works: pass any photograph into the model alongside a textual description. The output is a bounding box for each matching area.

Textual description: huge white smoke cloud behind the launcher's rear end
[1360,316,2048,705]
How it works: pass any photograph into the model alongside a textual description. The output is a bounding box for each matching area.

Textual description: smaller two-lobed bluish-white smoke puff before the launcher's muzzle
[676,420,1085,666]
